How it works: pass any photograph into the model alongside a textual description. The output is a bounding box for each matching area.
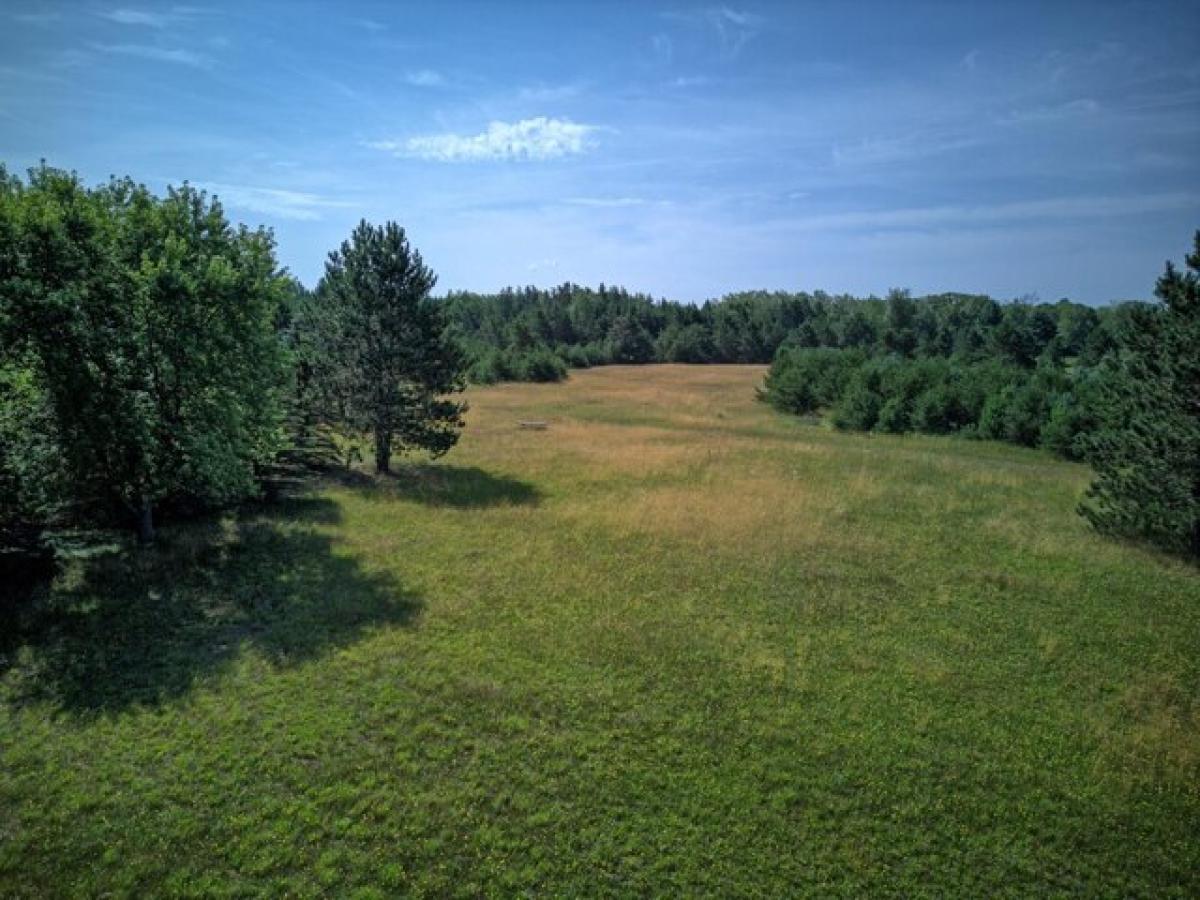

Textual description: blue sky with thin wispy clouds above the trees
[0,0,1200,302]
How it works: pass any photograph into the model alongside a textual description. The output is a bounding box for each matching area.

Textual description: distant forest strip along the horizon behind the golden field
[442,283,1111,382]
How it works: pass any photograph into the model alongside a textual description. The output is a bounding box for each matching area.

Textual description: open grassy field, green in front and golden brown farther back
[0,366,1200,896]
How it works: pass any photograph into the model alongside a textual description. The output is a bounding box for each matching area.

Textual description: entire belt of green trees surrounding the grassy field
[0,166,1200,564]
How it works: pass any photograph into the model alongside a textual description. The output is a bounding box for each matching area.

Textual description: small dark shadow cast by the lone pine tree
[338,463,541,509]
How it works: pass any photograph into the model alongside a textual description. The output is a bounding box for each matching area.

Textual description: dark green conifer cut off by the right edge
[1080,230,1200,558]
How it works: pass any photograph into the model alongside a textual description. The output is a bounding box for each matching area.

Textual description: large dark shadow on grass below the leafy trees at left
[0,498,422,714]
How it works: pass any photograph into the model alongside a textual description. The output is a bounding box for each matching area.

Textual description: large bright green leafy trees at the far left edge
[0,166,284,541]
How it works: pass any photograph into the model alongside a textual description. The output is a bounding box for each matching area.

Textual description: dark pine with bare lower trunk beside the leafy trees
[317,221,467,473]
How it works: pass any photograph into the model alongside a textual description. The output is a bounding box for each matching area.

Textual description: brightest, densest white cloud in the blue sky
[367,116,596,162]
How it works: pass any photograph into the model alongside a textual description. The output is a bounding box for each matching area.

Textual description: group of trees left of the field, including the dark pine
[0,164,466,565]
